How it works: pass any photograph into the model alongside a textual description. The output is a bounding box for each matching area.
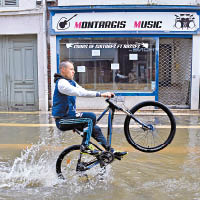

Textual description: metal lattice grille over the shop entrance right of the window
[159,38,192,108]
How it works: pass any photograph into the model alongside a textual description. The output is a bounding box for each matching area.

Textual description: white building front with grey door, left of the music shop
[0,0,48,110]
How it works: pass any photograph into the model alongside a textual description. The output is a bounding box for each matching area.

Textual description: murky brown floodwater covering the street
[0,113,200,200]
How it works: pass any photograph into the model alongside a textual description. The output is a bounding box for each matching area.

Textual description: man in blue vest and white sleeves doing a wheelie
[52,61,127,157]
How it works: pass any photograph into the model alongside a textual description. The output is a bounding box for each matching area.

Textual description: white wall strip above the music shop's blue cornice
[58,0,200,6]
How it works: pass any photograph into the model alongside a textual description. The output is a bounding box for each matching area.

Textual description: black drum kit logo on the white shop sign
[174,14,196,29]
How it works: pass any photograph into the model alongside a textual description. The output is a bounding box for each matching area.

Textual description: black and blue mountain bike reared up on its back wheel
[56,99,176,179]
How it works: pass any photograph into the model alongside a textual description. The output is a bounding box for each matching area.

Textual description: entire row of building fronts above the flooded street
[0,0,200,111]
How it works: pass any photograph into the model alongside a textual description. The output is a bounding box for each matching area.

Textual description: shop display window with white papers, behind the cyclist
[60,38,155,92]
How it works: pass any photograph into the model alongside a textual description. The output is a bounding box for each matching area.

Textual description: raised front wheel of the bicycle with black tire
[124,101,176,153]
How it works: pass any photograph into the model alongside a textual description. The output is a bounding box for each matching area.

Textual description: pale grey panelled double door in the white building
[0,36,38,110]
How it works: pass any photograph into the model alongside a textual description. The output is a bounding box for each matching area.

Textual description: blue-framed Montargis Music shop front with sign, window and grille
[49,6,199,108]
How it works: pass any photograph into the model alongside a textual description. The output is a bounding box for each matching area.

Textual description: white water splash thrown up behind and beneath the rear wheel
[0,129,112,194]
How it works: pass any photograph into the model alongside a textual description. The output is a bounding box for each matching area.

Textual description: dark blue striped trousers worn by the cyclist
[56,112,107,148]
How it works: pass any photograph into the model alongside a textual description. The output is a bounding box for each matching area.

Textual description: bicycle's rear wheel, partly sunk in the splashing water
[56,145,100,180]
